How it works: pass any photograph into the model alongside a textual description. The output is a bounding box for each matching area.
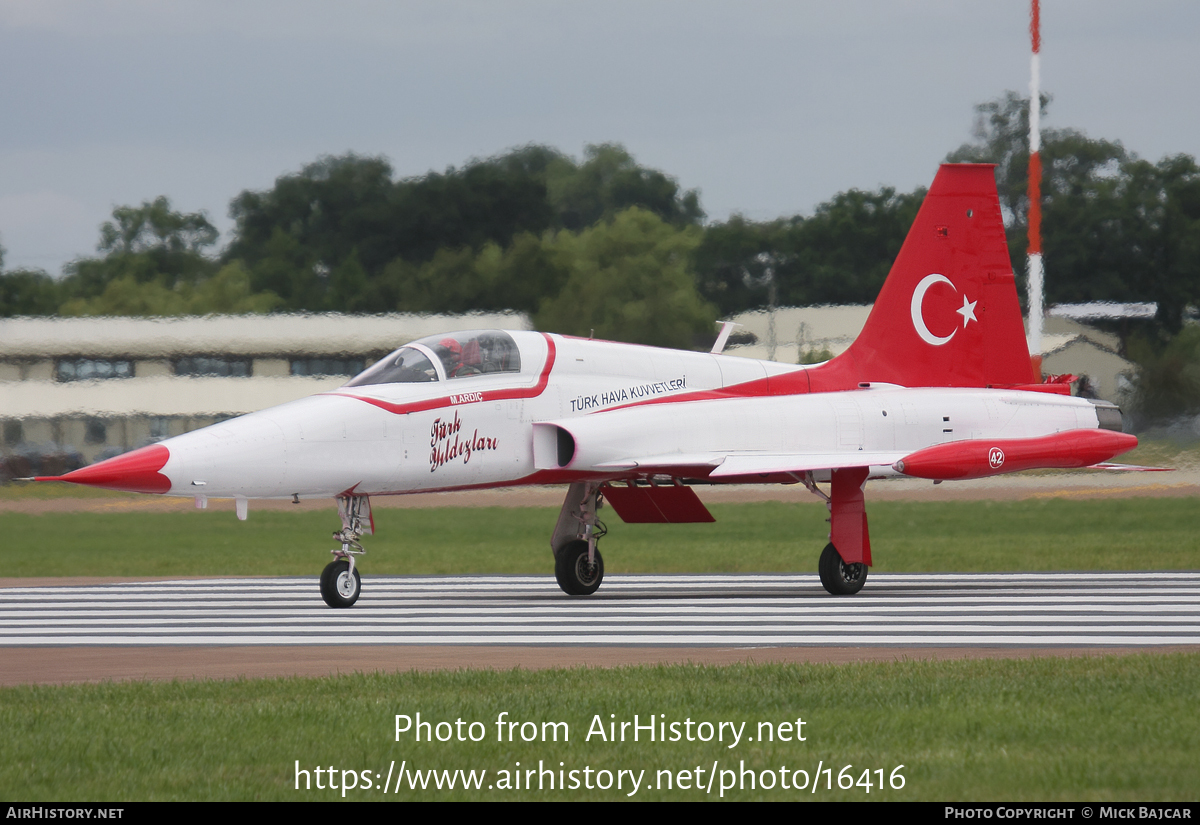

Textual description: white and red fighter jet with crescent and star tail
[40,165,1138,607]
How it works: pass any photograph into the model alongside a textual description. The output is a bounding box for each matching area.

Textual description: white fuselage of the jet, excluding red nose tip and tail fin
[150,332,1098,499]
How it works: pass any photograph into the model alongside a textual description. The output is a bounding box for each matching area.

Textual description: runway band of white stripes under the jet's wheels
[0,572,1200,646]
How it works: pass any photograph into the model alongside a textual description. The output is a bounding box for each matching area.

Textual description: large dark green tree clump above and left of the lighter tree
[223,144,703,312]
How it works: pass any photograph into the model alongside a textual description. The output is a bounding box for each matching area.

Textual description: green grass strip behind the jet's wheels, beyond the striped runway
[0,499,1200,577]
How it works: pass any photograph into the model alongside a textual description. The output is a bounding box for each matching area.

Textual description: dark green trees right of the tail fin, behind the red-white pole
[948,92,1200,335]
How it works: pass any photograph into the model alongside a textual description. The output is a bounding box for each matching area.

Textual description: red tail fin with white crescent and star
[809,164,1037,391]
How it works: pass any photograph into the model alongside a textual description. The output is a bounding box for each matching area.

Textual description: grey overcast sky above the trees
[0,0,1200,273]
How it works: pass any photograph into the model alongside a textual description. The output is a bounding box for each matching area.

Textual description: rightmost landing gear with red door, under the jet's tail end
[802,466,871,596]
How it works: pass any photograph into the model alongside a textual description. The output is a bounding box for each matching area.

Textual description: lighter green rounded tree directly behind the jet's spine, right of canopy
[535,206,716,348]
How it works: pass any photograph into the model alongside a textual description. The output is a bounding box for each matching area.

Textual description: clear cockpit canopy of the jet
[346,330,521,387]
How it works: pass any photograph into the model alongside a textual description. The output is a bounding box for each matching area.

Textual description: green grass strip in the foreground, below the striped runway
[0,655,1200,801]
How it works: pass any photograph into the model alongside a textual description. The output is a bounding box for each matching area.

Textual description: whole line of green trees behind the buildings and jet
[0,92,1200,414]
